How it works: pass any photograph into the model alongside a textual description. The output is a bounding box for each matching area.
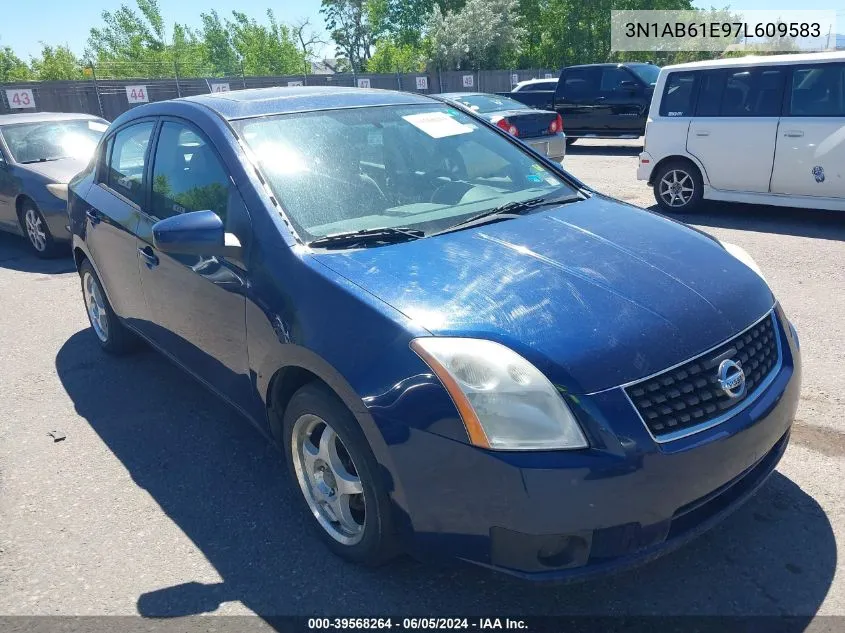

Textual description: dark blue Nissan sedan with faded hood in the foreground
[69,87,801,579]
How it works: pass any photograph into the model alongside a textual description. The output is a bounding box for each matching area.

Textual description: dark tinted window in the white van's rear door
[719,68,784,116]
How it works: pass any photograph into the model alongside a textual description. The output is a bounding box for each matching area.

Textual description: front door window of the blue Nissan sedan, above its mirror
[150,121,231,222]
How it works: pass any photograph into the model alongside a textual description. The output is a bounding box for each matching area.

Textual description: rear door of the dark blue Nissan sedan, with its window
[80,119,156,327]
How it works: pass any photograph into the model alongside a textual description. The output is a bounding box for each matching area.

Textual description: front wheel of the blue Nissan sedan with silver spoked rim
[284,383,397,566]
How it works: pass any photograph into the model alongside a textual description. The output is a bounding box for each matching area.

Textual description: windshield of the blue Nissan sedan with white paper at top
[233,104,575,241]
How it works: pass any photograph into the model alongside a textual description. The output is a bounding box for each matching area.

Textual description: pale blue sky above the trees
[0,0,845,59]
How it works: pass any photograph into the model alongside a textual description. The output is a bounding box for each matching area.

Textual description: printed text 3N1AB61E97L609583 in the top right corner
[625,22,822,39]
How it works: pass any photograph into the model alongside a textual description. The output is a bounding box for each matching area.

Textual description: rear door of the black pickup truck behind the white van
[555,66,607,136]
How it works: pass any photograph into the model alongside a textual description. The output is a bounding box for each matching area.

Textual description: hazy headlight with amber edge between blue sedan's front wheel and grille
[411,337,587,450]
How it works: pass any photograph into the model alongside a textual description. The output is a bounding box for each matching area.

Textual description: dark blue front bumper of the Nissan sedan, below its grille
[392,310,801,580]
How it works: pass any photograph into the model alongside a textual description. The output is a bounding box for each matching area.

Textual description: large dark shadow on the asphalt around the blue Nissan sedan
[56,329,837,626]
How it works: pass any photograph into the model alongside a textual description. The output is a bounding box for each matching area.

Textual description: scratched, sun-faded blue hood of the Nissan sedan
[315,195,774,393]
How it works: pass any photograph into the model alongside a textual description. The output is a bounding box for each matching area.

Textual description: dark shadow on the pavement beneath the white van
[648,200,845,241]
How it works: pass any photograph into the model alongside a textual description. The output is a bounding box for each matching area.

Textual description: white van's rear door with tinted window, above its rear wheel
[684,66,786,193]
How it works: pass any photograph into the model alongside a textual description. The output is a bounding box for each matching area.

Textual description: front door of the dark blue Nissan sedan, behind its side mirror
[136,120,251,403]
